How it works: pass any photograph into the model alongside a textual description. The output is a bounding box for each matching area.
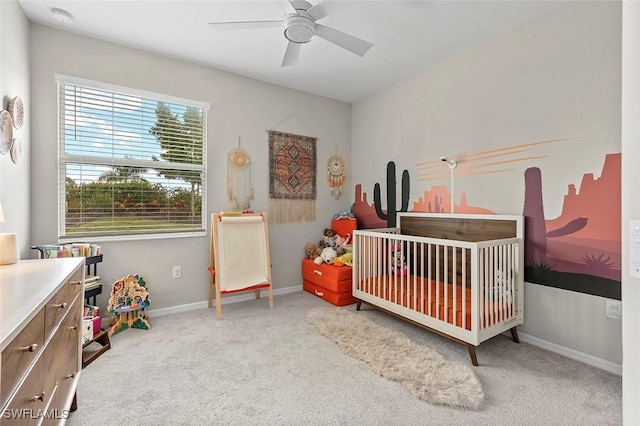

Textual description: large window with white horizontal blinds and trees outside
[56,75,209,241]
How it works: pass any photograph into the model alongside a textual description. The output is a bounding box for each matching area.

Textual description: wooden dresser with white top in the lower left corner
[0,257,84,426]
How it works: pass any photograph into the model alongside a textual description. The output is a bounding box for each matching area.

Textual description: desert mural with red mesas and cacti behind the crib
[352,139,622,300]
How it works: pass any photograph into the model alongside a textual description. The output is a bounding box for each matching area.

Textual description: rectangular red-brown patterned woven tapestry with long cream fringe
[268,130,317,223]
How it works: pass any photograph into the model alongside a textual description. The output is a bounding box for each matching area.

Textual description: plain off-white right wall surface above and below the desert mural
[351,2,622,368]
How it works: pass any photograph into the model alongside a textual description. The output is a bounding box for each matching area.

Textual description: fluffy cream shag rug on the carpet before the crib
[307,307,484,409]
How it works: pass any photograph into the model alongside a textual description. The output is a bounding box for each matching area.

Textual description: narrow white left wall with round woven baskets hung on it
[0,1,31,258]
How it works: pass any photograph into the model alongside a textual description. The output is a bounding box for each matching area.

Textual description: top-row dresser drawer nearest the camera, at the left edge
[0,310,44,407]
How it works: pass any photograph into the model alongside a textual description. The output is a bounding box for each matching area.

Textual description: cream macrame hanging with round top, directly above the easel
[227,138,253,211]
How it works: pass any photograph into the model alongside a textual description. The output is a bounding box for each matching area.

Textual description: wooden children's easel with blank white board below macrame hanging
[209,213,273,320]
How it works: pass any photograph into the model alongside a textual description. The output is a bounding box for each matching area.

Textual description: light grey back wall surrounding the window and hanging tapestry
[31,25,351,309]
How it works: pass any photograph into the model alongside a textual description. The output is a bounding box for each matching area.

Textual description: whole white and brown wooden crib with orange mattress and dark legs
[353,213,524,365]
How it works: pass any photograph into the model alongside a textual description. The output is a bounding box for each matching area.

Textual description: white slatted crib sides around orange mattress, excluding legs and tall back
[353,228,523,345]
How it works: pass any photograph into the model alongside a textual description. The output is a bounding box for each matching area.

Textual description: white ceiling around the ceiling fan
[18,0,563,102]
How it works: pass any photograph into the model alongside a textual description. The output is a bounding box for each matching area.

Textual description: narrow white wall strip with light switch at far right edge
[622,2,640,425]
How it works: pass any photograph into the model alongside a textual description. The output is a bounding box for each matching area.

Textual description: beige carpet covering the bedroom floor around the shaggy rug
[67,290,622,426]
